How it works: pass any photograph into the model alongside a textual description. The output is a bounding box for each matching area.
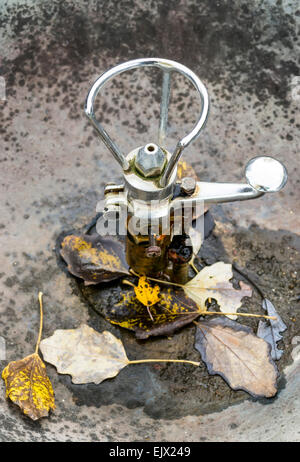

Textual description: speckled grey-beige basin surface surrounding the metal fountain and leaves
[0,0,300,441]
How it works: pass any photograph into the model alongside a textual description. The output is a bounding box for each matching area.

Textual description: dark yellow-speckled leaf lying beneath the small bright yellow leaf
[102,288,199,339]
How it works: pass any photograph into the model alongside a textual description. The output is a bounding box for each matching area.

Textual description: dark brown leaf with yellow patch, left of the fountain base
[60,234,128,285]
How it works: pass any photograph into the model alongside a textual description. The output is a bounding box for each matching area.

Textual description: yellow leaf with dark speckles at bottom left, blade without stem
[2,353,55,420]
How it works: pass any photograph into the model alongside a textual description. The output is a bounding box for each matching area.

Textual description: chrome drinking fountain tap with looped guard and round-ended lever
[85,58,287,274]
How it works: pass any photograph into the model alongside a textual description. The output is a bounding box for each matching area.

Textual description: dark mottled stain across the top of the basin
[1,0,300,105]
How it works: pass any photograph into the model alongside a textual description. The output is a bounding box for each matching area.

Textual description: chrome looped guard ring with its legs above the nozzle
[85,58,209,188]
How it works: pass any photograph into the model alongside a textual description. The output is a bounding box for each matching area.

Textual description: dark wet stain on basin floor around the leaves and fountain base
[50,208,300,419]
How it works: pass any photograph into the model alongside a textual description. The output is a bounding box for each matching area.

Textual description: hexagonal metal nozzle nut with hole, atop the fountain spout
[135,143,166,178]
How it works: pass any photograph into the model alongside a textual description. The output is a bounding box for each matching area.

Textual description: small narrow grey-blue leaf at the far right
[257,298,287,361]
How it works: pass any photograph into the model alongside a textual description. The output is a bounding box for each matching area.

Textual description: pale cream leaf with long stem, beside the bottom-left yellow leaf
[41,324,199,384]
